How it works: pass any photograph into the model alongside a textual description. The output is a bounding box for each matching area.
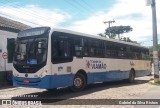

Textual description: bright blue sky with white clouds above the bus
[0,0,160,46]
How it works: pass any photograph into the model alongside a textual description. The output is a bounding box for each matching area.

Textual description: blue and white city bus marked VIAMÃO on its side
[13,27,150,91]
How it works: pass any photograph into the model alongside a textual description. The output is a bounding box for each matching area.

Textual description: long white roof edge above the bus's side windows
[51,28,148,49]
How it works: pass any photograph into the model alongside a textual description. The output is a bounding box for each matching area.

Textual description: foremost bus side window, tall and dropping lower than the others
[52,34,73,63]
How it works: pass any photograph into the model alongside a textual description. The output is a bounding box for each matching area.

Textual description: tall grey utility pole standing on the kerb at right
[146,0,160,83]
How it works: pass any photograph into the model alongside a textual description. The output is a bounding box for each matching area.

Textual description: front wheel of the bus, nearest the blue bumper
[71,73,86,92]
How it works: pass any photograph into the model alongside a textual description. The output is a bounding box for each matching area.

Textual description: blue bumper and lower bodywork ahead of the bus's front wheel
[13,74,74,89]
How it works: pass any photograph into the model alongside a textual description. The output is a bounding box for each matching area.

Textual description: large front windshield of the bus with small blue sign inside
[14,36,48,65]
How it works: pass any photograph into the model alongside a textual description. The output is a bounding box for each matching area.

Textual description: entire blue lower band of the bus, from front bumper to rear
[13,70,149,89]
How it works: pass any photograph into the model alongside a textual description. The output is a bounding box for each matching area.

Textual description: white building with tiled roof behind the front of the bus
[0,16,30,87]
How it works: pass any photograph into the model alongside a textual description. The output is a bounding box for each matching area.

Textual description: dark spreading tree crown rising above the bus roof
[105,26,133,40]
